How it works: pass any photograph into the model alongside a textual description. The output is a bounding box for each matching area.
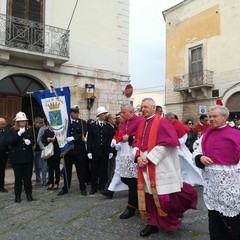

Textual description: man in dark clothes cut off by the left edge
[0,118,8,192]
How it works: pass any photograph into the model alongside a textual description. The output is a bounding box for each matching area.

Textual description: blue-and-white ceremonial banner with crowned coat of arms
[34,87,73,156]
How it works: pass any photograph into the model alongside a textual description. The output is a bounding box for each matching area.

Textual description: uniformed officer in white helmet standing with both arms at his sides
[87,107,115,195]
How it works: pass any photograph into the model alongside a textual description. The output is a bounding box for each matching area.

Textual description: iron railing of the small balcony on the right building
[173,70,213,91]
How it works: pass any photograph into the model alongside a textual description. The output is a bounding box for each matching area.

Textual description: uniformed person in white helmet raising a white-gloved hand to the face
[7,112,34,203]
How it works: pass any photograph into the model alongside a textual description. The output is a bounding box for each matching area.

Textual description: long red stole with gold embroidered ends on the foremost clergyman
[137,114,167,218]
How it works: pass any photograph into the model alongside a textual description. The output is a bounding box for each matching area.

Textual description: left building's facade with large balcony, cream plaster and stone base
[0,0,130,123]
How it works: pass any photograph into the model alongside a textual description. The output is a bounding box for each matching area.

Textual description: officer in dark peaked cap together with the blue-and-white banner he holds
[34,86,75,193]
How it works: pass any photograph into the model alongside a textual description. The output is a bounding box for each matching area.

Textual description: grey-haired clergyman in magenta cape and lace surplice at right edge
[194,105,240,240]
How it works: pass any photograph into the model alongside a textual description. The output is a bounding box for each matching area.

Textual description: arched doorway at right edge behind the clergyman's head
[226,91,240,121]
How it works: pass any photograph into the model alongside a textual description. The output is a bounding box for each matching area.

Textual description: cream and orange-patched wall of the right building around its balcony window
[163,0,240,123]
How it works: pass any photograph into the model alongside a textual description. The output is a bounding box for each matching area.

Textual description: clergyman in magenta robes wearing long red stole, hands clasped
[133,98,197,237]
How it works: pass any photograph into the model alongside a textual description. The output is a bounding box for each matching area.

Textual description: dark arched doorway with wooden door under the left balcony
[0,75,45,125]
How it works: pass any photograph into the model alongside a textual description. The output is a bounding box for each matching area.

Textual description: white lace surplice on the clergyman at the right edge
[203,162,240,217]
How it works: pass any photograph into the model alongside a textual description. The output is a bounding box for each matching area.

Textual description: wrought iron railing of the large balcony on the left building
[0,14,69,58]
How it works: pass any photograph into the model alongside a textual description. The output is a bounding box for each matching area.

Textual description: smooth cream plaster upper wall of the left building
[46,0,129,74]
